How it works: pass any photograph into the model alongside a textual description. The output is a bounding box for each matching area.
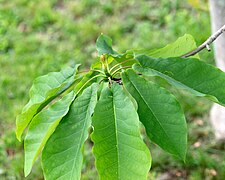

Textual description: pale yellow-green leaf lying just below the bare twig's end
[128,34,199,58]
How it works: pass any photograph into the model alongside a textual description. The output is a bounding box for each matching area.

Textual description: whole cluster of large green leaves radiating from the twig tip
[16,34,225,180]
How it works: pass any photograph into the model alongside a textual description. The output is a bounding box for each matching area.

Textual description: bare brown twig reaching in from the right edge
[181,25,225,58]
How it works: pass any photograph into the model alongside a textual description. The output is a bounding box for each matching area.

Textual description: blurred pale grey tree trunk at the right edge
[209,0,225,140]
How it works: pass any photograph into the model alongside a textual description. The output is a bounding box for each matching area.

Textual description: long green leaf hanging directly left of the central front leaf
[42,83,97,180]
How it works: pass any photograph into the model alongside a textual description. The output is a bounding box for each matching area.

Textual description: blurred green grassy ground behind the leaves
[0,0,225,180]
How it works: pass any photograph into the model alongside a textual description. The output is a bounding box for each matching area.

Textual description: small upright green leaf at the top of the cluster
[96,34,115,55]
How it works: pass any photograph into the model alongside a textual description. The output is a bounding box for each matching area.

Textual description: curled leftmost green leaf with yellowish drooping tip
[16,65,80,141]
